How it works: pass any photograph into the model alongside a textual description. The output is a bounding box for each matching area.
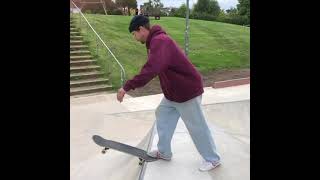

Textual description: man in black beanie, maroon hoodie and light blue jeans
[117,15,220,171]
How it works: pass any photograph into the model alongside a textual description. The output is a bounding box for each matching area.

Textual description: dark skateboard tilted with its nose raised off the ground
[92,135,158,165]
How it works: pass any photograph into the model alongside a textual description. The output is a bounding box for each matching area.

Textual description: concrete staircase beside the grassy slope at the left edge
[70,19,112,96]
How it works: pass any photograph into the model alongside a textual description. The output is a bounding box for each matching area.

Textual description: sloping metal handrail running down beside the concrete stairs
[70,0,126,86]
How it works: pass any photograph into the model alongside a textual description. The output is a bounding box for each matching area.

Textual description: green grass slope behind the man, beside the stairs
[70,14,250,87]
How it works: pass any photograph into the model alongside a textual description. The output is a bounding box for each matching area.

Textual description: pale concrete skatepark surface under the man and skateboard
[70,84,250,180]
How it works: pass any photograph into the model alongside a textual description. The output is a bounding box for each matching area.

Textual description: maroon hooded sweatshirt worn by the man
[123,25,203,103]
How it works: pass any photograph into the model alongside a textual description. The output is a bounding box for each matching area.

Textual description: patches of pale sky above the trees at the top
[137,0,238,10]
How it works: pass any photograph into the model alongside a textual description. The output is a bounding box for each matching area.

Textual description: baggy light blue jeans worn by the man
[155,95,220,162]
